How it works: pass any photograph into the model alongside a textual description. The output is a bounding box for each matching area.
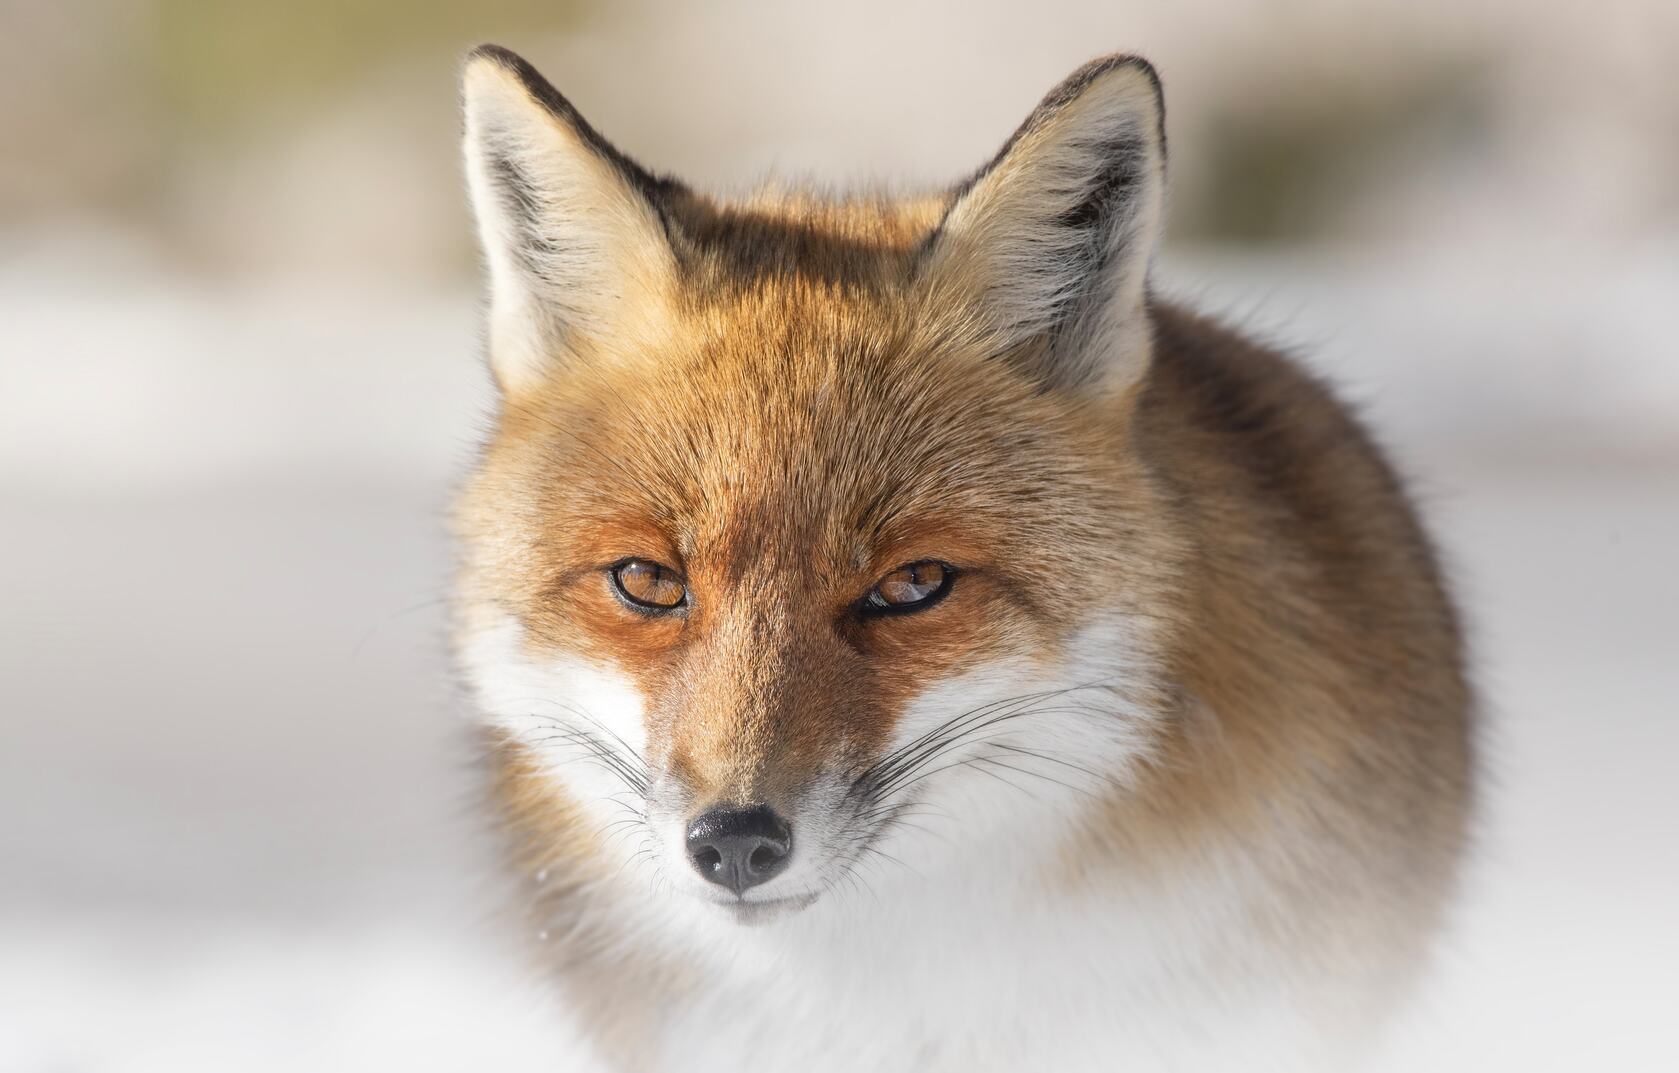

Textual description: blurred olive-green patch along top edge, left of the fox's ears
[153,0,601,131]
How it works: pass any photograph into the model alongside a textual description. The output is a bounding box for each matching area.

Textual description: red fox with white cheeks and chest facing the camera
[453,45,1476,1073]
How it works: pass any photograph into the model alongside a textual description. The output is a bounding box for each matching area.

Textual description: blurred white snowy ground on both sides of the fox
[0,253,1679,1073]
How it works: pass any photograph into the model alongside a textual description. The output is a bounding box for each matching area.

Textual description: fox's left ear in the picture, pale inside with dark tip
[462,45,680,393]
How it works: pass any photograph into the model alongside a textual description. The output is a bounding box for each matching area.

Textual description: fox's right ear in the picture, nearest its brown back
[923,55,1165,390]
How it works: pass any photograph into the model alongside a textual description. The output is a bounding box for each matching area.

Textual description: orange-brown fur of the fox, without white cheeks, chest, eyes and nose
[457,44,1472,1068]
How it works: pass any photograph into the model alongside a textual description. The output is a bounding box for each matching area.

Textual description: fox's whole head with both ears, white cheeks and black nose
[458,47,1179,919]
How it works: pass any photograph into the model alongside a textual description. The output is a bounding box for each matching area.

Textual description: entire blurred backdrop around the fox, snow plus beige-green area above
[0,0,1679,1073]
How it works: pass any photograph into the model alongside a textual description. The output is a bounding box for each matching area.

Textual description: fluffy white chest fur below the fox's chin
[597,863,1345,1073]
